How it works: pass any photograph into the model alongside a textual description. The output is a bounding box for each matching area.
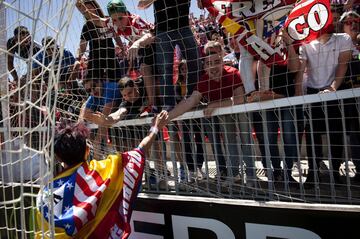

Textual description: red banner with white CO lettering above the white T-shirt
[285,0,333,43]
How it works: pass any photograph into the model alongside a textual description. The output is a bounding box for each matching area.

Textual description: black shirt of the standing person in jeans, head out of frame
[154,0,190,32]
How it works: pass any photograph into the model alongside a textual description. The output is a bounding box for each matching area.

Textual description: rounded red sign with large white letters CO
[286,1,332,41]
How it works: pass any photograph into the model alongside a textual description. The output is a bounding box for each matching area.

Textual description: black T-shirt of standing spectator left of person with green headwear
[80,21,120,81]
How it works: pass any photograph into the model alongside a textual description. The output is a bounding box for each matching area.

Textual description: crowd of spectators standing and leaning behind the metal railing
[4,0,360,191]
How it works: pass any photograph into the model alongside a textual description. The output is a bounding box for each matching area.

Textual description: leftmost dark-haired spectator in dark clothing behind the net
[7,26,41,82]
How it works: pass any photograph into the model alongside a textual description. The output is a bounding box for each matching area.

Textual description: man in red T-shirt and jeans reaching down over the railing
[169,41,255,186]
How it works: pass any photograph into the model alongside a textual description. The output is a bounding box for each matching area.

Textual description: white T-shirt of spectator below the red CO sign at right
[300,33,353,89]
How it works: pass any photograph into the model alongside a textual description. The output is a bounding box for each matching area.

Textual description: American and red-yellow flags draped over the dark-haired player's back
[37,149,145,239]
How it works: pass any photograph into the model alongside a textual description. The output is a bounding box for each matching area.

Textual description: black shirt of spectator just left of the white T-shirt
[269,65,296,97]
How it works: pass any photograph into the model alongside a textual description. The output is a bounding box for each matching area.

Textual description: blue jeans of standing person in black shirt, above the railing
[156,27,200,110]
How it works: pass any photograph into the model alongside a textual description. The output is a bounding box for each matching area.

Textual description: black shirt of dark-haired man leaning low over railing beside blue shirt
[120,79,146,120]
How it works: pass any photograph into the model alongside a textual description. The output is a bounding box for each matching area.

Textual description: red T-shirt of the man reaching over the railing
[197,65,242,102]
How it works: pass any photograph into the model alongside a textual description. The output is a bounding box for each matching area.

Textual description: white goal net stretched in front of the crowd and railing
[0,0,360,238]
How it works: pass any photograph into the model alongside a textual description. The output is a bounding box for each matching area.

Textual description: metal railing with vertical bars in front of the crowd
[105,89,360,204]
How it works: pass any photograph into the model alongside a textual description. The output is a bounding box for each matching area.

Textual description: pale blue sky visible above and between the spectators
[5,0,203,54]
